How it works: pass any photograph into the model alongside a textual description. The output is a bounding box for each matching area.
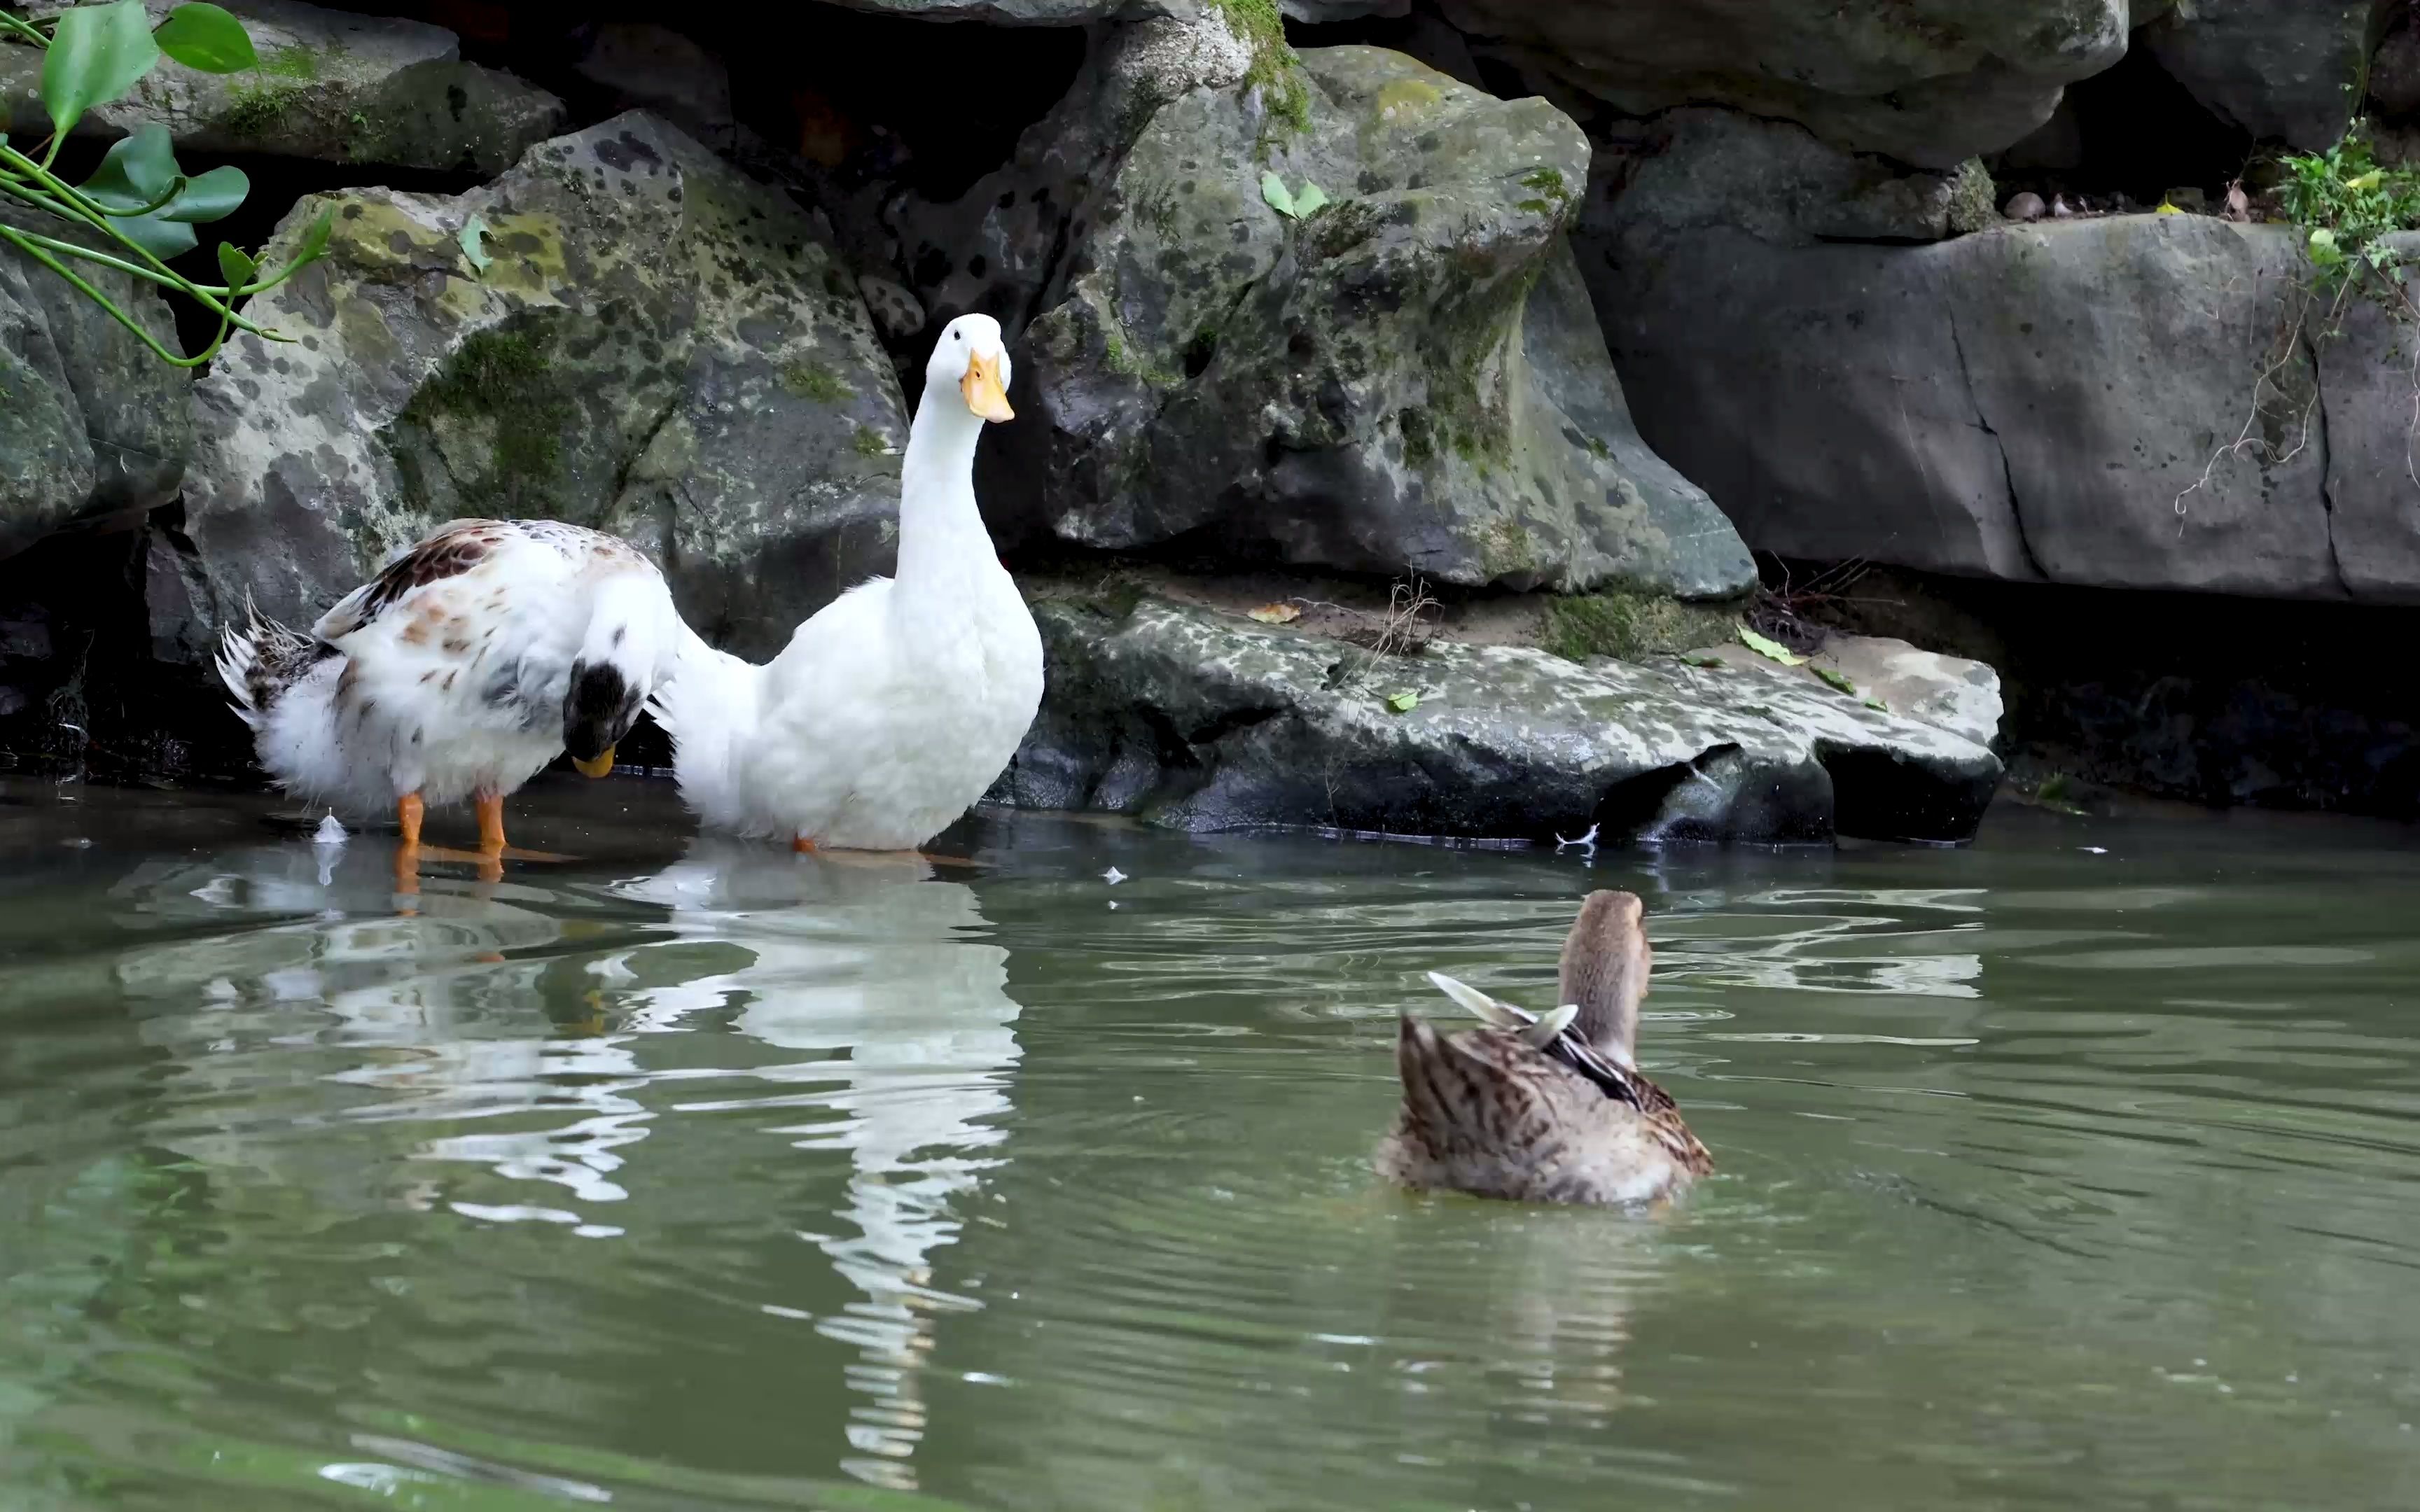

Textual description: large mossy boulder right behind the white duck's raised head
[1021,46,1752,598]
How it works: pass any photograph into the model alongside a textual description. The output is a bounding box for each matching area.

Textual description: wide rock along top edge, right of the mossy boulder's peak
[1445,0,2129,167]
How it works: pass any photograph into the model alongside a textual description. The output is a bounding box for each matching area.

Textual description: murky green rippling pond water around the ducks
[0,779,2420,1512]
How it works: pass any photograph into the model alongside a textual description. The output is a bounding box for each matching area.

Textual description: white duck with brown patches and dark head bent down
[218,520,685,876]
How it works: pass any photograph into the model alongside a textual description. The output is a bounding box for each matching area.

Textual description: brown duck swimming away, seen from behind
[1377,892,1713,1203]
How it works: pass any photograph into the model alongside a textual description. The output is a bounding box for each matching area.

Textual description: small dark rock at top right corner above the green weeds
[2137,0,2386,153]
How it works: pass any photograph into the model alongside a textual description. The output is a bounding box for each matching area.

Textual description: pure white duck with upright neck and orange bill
[651,314,1043,852]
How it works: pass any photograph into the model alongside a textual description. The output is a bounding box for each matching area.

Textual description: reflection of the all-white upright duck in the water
[600,837,1019,1490]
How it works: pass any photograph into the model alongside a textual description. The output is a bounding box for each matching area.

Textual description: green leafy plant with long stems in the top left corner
[0,0,336,368]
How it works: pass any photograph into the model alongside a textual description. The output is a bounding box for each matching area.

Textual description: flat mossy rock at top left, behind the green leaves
[0,0,564,176]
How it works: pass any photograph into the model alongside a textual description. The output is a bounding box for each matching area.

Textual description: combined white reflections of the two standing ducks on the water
[113,839,1019,1490]
